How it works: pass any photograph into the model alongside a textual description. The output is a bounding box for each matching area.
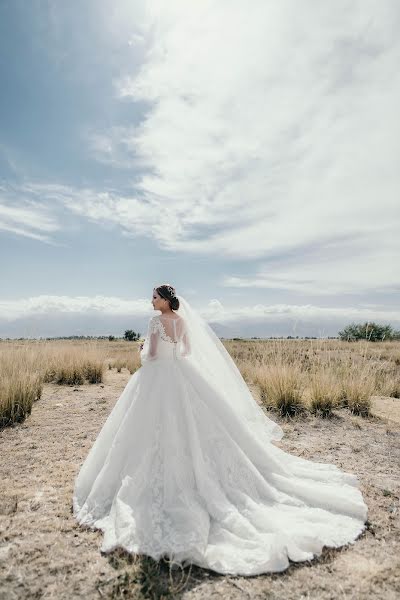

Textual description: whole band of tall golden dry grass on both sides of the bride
[0,339,400,426]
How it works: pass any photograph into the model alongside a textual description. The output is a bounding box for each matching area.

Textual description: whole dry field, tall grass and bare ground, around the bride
[0,340,400,600]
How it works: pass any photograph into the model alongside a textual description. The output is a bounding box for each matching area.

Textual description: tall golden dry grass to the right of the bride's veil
[228,339,400,418]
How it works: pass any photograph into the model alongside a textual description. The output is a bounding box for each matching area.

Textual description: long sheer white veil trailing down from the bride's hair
[176,295,284,441]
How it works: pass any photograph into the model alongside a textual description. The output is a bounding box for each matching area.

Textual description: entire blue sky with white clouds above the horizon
[0,0,400,337]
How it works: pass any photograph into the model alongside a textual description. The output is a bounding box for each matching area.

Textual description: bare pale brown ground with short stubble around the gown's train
[0,372,400,600]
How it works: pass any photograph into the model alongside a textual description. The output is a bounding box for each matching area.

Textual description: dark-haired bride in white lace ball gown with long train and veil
[73,285,368,575]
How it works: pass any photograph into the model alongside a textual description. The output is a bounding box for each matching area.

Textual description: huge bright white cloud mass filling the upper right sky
[76,0,400,293]
